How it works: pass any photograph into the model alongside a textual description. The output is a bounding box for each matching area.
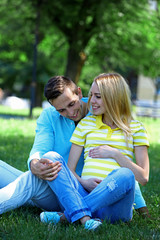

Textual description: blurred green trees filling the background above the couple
[0,0,160,109]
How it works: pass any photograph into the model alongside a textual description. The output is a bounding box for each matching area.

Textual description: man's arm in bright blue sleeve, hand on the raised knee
[28,108,61,181]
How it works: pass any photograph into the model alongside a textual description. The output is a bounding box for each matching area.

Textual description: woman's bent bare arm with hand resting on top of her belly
[89,145,149,185]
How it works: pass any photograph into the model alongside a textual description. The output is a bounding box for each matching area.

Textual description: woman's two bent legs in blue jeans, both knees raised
[43,152,135,222]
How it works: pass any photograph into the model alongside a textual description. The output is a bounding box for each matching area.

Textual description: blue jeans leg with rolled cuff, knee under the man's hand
[43,152,91,222]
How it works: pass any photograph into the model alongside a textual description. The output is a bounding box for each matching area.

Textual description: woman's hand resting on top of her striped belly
[89,145,117,158]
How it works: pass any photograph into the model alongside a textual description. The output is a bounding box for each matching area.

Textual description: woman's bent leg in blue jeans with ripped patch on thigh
[84,168,135,223]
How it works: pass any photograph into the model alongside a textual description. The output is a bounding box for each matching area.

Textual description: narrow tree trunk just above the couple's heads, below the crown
[65,45,86,84]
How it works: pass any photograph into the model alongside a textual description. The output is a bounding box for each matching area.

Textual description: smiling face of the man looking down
[50,87,82,122]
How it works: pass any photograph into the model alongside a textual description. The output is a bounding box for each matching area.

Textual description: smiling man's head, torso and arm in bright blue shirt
[28,76,87,181]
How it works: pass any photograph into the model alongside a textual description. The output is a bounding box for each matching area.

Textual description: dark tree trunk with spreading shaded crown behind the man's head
[40,0,103,83]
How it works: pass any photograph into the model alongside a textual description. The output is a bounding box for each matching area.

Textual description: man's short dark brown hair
[44,76,78,101]
